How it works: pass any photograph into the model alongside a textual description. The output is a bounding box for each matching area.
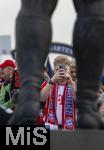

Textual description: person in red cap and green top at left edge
[0,60,16,109]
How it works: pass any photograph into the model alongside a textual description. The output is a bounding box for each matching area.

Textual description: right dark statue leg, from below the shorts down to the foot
[74,18,104,129]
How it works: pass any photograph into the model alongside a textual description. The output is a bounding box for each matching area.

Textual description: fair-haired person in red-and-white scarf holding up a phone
[41,56,76,130]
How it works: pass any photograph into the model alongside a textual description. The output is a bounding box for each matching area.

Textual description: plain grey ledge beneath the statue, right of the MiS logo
[50,130,104,150]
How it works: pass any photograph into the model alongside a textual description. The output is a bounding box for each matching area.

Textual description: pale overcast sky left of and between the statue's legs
[0,0,76,48]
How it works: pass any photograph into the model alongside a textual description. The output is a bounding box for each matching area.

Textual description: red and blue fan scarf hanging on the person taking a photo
[37,83,76,130]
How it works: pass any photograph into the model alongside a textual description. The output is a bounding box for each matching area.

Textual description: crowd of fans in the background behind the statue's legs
[0,55,104,130]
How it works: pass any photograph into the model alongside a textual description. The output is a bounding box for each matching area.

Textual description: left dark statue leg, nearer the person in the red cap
[9,0,57,124]
